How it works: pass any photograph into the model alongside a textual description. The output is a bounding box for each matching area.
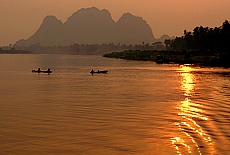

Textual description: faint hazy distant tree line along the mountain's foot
[11,42,165,55]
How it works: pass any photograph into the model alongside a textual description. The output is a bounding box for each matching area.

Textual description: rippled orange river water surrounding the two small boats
[0,54,230,155]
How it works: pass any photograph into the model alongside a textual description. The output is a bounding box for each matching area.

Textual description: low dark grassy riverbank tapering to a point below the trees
[103,50,230,67]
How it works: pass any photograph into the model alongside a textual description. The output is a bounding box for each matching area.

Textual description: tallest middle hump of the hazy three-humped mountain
[63,8,116,44]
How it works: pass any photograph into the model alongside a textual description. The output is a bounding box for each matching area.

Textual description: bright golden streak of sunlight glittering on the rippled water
[171,65,212,155]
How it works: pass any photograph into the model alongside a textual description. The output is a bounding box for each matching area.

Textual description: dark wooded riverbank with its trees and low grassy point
[104,21,230,67]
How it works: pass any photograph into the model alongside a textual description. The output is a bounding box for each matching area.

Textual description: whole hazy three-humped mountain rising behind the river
[15,7,172,46]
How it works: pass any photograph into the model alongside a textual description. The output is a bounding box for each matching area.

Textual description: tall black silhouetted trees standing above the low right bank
[164,20,230,53]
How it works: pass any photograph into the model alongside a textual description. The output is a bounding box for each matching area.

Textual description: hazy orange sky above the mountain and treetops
[0,0,230,46]
